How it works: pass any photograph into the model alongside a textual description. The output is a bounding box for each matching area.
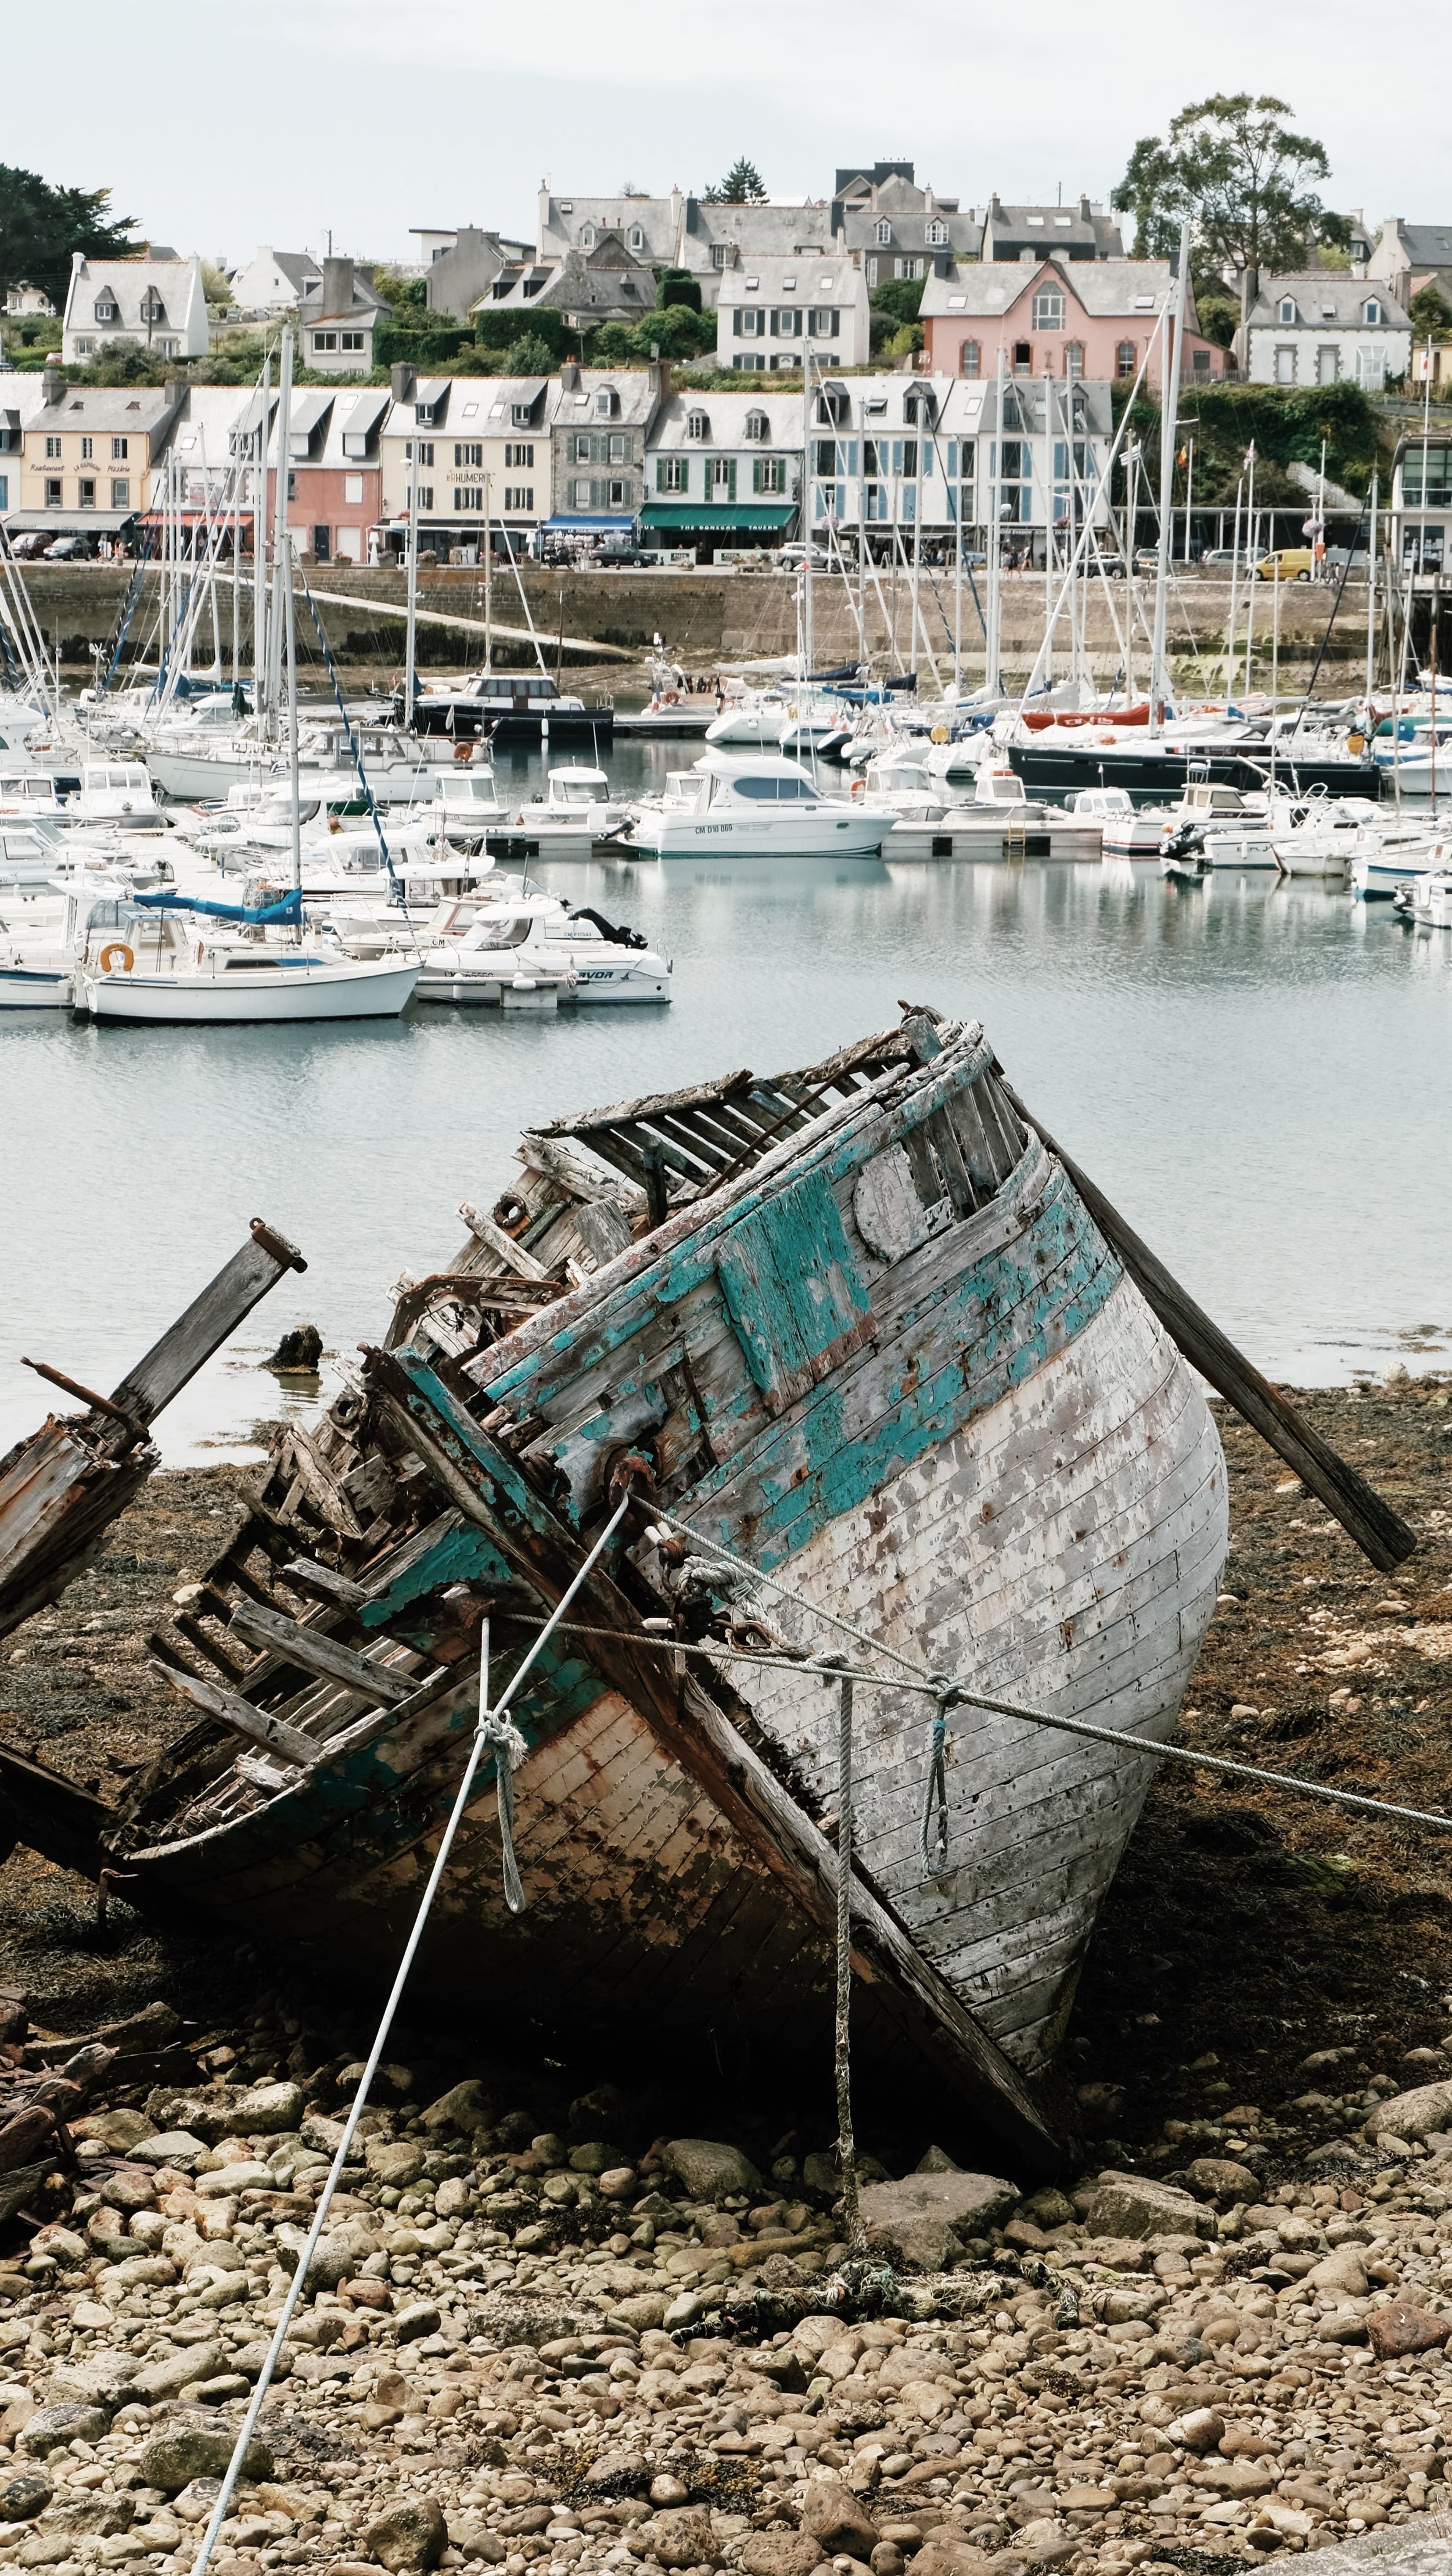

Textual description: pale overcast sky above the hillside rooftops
[14,0,1452,260]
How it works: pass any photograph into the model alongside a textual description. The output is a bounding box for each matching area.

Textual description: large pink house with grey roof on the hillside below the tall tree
[922,250,1225,389]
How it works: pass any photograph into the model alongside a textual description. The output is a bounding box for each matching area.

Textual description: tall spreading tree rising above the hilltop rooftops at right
[1109,90,1349,278]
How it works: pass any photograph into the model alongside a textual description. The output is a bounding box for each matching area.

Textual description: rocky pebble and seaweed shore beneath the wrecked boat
[0,1384,1452,2576]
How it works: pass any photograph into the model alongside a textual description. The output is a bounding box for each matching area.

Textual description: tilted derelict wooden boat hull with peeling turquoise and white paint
[0,1010,1390,2169]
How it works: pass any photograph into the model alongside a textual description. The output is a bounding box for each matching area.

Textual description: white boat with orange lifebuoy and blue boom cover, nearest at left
[75,896,420,1028]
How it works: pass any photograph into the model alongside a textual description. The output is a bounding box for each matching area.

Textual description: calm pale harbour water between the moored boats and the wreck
[0,745,1452,1463]
